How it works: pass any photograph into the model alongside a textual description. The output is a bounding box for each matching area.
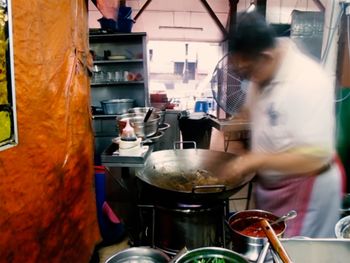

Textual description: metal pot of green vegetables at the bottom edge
[175,247,249,263]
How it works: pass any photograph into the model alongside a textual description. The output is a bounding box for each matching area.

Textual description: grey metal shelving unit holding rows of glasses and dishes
[89,31,150,162]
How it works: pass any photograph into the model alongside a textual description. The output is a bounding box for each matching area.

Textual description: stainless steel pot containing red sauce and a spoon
[228,210,286,261]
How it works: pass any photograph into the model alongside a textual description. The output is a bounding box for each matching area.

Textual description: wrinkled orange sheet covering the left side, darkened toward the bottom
[0,0,99,263]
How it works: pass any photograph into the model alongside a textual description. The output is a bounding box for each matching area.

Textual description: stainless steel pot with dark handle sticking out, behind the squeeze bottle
[117,113,160,138]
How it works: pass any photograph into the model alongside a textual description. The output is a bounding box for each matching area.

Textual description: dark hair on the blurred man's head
[228,11,276,56]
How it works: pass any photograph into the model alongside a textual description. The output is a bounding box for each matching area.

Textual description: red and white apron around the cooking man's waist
[254,165,342,238]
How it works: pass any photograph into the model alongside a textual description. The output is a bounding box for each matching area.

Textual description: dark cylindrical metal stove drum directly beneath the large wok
[154,202,224,255]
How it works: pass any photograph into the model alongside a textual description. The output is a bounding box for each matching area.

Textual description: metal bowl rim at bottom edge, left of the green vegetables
[105,247,170,263]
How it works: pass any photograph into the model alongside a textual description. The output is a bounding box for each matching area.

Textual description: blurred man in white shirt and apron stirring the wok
[221,12,342,238]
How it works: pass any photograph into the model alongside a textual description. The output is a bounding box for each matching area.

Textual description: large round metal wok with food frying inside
[136,149,254,202]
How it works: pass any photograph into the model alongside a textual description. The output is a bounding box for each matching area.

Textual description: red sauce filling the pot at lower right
[230,216,284,238]
